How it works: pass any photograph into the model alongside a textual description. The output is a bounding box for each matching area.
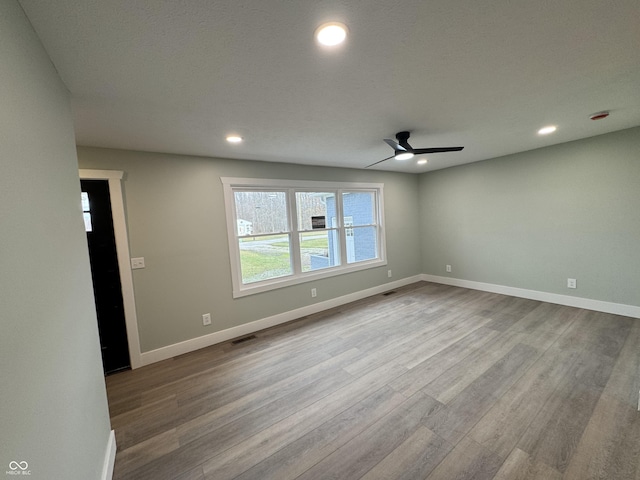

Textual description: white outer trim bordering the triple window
[220,177,387,298]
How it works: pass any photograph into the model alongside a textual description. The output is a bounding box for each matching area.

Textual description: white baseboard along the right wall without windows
[420,274,640,318]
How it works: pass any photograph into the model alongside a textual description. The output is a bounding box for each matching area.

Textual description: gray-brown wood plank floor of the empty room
[107,282,640,480]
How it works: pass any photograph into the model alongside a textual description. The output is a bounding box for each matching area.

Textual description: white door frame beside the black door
[79,169,142,368]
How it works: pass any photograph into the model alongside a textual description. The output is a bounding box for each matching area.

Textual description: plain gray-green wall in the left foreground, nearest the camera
[0,0,110,480]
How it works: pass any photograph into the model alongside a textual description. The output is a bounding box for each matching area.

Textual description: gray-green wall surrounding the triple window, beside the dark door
[78,147,421,352]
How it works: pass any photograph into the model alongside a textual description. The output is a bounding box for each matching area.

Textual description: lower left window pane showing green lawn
[238,235,293,284]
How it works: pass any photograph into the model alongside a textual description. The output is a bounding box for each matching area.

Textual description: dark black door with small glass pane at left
[80,180,131,374]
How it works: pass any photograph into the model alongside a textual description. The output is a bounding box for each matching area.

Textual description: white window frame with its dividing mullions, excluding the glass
[220,177,387,298]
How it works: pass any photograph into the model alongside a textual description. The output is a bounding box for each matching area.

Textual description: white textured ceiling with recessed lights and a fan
[20,0,640,172]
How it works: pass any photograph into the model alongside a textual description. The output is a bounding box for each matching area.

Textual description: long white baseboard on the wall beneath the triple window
[141,275,421,365]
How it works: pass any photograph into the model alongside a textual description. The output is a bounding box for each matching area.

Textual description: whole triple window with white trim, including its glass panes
[222,178,386,297]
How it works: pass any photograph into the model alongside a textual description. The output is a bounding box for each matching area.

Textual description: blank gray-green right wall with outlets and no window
[420,128,640,306]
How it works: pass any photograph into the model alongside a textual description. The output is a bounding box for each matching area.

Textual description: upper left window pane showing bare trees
[234,191,289,237]
